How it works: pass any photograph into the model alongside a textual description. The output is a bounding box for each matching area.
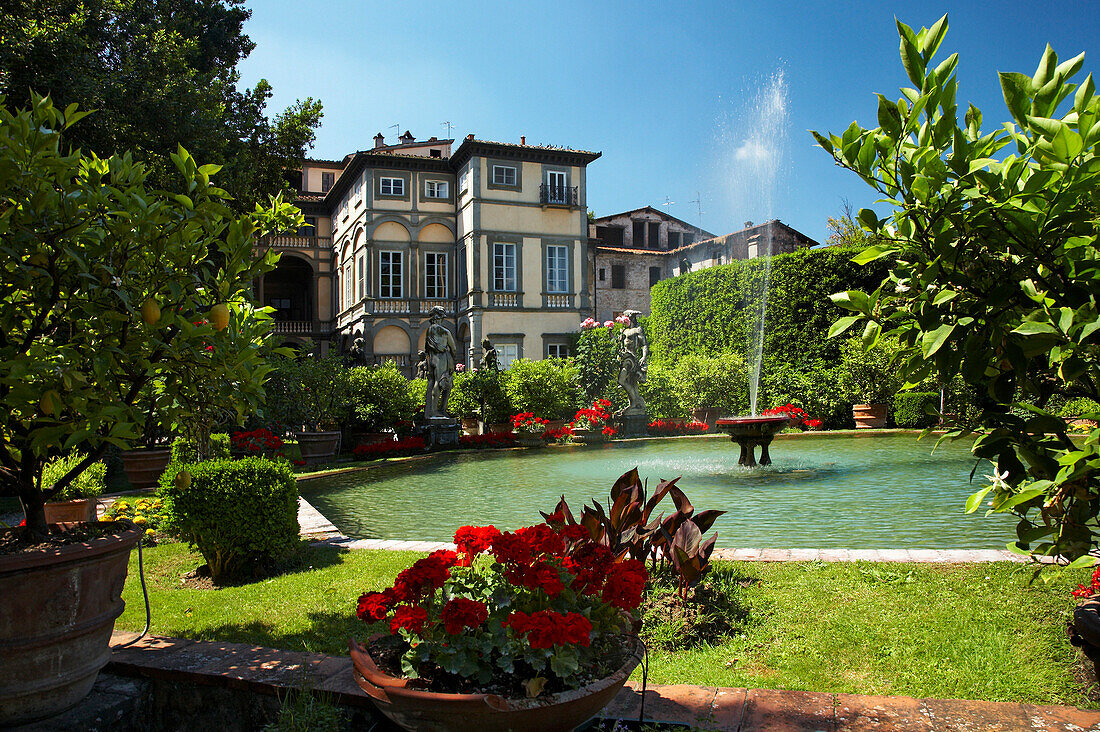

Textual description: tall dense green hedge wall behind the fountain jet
[646,247,890,370]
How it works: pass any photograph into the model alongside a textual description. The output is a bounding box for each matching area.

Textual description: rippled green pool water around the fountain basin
[301,434,1014,549]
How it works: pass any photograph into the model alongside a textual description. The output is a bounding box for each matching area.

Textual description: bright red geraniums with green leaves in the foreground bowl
[355,524,648,697]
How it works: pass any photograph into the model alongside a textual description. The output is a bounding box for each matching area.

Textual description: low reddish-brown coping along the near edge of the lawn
[106,632,1100,732]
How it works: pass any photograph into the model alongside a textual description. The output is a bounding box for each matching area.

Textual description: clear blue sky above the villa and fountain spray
[240,0,1100,241]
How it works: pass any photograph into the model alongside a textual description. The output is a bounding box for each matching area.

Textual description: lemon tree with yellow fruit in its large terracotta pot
[0,97,300,726]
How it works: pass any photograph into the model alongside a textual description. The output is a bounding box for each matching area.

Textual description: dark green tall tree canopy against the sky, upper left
[0,0,322,211]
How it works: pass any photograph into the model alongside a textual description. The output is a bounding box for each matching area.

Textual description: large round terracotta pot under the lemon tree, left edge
[0,522,141,726]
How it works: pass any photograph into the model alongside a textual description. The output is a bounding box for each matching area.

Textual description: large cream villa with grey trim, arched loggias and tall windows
[257,132,600,373]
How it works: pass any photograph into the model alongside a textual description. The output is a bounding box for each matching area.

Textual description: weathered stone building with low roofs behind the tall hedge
[589,215,817,320]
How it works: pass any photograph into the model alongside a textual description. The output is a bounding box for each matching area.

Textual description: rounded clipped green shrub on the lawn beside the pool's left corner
[160,458,298,582]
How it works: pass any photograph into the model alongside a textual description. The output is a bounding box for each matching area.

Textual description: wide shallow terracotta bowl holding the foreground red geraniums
[348,638,642,732]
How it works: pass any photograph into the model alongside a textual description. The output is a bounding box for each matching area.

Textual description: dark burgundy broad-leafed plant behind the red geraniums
[542,468,725,599]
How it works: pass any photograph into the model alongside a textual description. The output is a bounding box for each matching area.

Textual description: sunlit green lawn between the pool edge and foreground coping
[118,544,1097,707]
